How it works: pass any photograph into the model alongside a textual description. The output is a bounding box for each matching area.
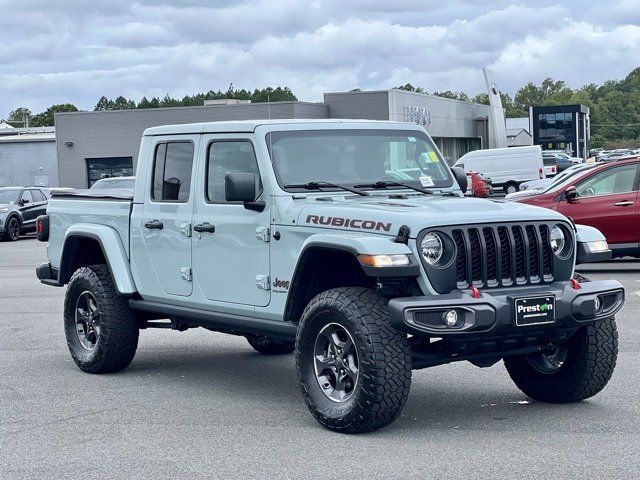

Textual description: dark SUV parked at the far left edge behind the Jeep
[0,187,48,241]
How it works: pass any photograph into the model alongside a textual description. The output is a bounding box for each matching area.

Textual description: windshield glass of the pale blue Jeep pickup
[266,130,453,191]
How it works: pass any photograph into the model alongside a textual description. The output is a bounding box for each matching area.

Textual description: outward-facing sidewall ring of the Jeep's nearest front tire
[296,306,370,424]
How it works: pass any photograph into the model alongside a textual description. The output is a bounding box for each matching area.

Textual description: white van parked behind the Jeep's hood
[454,145,545,193]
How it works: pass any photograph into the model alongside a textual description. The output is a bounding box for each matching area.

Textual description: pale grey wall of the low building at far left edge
[0,139,59,187]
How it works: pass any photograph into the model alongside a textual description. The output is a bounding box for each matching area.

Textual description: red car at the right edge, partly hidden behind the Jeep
[516,158,640,257]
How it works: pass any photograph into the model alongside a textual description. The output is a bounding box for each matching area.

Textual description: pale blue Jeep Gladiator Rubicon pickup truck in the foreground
[36,120,624,432]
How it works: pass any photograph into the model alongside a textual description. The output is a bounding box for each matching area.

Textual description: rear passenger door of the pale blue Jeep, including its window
[137,136,198,296]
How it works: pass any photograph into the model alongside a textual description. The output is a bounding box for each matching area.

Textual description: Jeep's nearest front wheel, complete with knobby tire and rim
[296,288,411,433]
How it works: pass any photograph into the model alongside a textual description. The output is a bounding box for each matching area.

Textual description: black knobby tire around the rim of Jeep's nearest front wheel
[295,287,411,433]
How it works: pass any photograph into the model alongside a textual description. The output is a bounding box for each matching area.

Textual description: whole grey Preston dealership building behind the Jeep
[55,89,504,188]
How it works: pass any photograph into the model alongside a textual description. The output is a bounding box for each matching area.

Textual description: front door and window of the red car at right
[558,164,640,244]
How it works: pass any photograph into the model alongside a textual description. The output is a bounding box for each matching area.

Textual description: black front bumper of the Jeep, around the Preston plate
[389,280,624,340]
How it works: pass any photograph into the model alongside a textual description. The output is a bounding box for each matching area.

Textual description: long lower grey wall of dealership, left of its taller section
[55,102,327,188]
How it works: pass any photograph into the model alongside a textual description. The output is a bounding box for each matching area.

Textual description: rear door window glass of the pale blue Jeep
[151,142,193,203]
